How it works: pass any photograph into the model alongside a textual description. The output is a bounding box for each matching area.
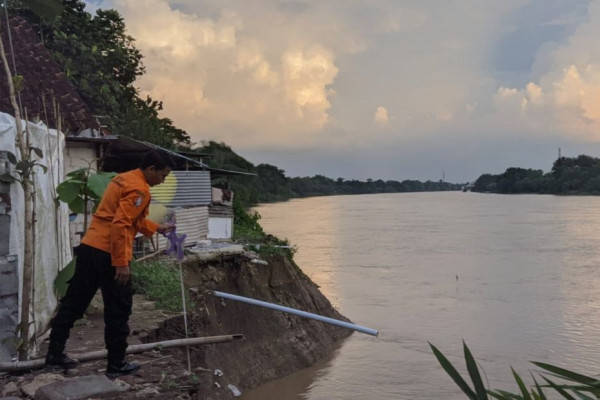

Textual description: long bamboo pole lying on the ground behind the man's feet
[0,334,244,372]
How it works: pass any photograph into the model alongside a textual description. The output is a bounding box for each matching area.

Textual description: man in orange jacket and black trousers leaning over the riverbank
[46,150,173,377]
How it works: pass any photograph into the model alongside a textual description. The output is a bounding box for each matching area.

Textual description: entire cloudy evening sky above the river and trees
[87,0,600,182]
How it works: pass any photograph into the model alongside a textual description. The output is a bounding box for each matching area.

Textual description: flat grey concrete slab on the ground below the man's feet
[34,375,126,400]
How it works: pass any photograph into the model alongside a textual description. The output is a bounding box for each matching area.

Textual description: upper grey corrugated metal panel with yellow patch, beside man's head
[150,171,212,207]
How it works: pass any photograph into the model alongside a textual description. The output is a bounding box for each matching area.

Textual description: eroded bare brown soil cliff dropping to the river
[146,255,351,398]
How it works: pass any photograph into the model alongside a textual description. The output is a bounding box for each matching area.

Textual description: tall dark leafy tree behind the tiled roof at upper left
[13,0,191,148]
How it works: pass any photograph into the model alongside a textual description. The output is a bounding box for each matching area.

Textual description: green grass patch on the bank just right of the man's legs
[131,261,182,311]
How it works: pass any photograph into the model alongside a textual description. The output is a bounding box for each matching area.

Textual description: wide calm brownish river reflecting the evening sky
[243,192,600,400]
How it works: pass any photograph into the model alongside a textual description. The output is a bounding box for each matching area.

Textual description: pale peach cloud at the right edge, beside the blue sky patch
[496,1,600,141]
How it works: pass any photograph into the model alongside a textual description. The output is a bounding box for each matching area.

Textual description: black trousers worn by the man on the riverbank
[48,244,132,364]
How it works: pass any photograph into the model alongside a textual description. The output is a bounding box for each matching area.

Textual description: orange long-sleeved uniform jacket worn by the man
[81,169,158,267]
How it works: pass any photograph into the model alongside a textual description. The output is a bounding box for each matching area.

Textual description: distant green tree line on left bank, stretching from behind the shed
[195,141,463,206]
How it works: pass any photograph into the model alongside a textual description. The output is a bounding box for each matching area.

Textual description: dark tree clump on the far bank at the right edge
[471,155,600,194]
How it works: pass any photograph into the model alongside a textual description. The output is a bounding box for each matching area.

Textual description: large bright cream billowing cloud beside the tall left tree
[114,0,338,147]
